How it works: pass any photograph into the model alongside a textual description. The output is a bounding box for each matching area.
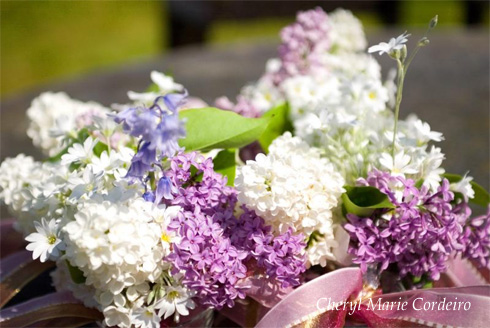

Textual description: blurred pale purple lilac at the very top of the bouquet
[274,7,330,83]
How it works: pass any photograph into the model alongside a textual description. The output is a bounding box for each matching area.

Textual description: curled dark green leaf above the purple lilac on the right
[342,186,395,217]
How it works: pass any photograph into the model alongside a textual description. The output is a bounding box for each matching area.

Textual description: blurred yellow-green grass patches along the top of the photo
[0,0,488,97]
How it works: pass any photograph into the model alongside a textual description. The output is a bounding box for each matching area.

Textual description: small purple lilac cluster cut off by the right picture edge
[463,207,490,267]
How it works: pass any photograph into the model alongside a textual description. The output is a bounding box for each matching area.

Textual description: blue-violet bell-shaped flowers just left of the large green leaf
[114,93,187,181]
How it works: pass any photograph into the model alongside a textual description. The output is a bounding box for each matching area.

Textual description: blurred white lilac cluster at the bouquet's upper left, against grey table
[27,92,110,156]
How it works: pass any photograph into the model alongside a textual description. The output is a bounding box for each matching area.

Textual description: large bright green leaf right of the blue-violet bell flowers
[179,107,270,151]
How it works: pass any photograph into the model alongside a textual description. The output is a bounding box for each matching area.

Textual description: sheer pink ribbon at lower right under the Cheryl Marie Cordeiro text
[256,268,490,328]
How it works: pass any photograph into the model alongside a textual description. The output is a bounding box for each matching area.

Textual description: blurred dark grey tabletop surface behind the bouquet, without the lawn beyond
[0,29,490,195]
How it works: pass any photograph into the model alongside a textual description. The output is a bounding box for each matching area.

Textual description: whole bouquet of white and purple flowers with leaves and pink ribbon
[0,8,490,328]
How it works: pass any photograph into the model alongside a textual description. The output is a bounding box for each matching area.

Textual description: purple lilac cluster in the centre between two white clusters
[166,152,306,308]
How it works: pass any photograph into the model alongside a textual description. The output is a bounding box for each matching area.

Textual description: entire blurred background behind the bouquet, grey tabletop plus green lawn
[0,0,490,204]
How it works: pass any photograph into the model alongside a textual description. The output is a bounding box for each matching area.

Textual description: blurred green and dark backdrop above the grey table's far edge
[0,0,489,98]
